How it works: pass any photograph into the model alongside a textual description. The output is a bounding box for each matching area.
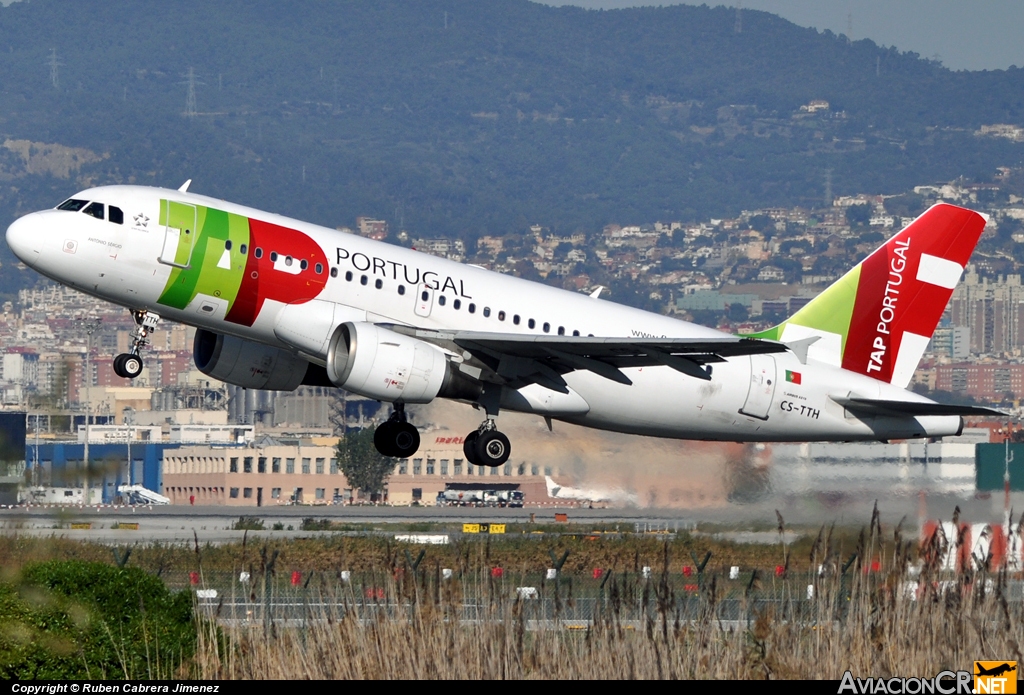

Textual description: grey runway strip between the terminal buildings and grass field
[0,483,1024,544]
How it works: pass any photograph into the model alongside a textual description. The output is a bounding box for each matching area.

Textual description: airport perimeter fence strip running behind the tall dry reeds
[164,567,1024,629]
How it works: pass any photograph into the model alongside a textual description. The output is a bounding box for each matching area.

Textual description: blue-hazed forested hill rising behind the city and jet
[0,0,1024,253]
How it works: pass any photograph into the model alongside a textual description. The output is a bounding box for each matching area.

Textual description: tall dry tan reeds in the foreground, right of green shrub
[195,519,1024,680]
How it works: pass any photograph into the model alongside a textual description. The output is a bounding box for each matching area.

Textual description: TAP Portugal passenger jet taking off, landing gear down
[6,180,1001,467]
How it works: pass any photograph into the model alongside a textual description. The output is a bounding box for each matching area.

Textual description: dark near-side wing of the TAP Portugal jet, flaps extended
[388,327,788,393]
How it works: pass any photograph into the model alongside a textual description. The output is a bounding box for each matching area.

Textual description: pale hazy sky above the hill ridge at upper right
[547,0,1024,70]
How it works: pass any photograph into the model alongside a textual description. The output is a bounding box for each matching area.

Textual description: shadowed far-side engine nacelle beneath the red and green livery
[193,329,309,391]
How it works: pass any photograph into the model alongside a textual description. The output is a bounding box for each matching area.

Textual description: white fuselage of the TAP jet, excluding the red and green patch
[7,186,962,441]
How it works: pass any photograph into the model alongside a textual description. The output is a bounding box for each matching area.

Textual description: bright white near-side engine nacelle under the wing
[327,321,460,403]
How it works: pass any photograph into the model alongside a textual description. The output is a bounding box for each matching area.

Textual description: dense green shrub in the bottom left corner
[0,560,197,680]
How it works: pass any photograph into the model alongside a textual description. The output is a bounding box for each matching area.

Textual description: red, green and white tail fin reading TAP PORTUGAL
[754,203,985,388]
